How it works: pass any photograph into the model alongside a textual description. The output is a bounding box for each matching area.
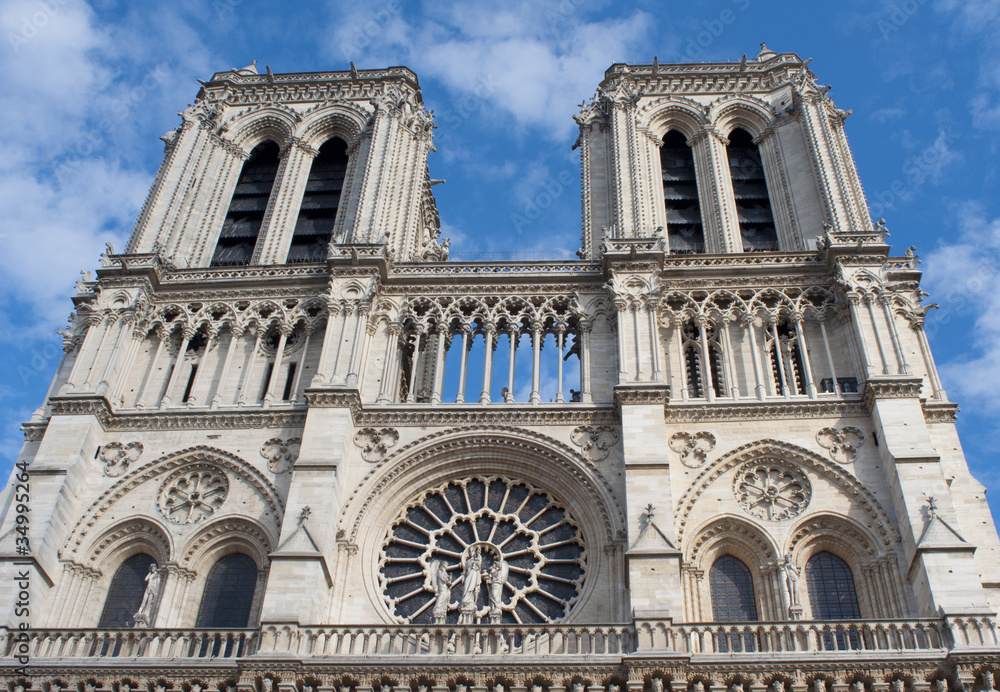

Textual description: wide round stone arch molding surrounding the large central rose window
[337,426,625,622]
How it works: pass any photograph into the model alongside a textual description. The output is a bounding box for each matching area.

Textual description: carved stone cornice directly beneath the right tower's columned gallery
[665,399,868,423]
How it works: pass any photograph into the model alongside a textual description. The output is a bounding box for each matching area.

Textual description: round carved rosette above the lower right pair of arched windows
[733,459,812,521]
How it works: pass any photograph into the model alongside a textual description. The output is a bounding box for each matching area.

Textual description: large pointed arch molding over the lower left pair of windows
[62,445,284,558]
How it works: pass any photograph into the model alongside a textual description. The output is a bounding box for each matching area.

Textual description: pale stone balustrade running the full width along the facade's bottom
[7,617,1000,660]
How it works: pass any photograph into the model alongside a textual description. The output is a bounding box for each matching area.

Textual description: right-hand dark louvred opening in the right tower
[728,128,778,252]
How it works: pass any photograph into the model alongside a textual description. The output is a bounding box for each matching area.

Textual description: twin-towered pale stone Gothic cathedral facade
[0,46,1000,692]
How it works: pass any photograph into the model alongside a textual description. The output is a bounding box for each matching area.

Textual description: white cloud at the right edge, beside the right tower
[924,204,1000,413]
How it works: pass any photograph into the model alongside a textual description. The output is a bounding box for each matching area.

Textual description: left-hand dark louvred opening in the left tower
[212,142,280,267]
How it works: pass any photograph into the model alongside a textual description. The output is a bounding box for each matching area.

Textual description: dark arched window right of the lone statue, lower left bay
[196,553,257,629]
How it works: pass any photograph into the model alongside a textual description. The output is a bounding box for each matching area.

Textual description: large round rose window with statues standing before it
[379,477,586,624]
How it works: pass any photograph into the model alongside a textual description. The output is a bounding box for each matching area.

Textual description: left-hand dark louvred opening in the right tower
[660,130,705,254]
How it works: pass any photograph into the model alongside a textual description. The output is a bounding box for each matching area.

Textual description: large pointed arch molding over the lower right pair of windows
[677,439,900,551]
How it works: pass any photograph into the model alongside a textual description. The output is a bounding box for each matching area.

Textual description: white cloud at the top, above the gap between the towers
[329,0,655,139]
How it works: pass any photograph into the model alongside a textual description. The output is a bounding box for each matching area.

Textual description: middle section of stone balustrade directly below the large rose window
[258,625,635,658]
